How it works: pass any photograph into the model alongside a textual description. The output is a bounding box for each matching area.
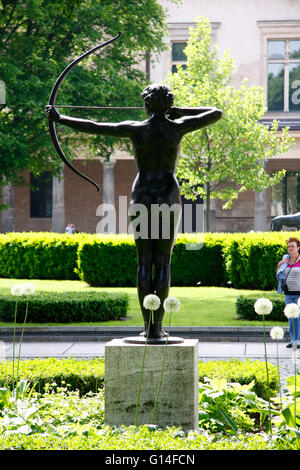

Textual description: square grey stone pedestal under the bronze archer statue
[105,339,198,430]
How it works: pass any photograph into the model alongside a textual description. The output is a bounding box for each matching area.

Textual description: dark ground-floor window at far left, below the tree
[30,172,52,218]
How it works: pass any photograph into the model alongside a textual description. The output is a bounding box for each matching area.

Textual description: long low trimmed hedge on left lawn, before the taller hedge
[0,292,128,323]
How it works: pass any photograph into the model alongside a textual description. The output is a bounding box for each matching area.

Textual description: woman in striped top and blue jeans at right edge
[276,238,300,348]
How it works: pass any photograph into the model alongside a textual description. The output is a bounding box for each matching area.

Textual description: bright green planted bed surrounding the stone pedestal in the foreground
[0,358,295,450]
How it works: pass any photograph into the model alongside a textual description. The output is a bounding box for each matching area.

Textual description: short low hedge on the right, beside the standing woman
[236,293,287,322]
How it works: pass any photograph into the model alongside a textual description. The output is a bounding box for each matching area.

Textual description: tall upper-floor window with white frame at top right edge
[267,39,300,112]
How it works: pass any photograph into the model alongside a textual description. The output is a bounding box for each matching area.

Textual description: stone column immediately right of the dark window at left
[52,168,65,233]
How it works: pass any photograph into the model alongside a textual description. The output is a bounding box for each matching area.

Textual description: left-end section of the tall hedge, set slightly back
[0,232,85,279]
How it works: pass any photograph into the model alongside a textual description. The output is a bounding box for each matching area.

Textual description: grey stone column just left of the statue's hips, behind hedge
[97,159,117,233]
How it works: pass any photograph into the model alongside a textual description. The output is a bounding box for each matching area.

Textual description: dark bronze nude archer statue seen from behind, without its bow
[46,84,222,339]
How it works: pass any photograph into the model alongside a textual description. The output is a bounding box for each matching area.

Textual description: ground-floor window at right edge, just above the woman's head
[271,171,300,217]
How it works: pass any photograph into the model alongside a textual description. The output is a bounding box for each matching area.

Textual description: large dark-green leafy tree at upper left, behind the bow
[0,0,166,184]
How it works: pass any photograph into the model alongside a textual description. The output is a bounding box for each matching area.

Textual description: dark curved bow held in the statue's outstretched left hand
[48,33,121,191]
